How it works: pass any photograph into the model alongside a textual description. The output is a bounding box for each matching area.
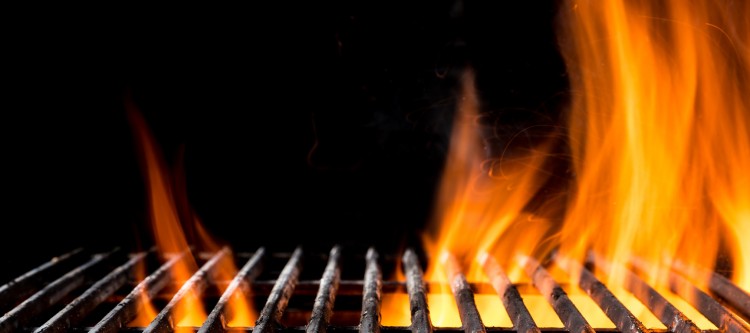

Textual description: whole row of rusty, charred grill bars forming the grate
[0,246,750,333]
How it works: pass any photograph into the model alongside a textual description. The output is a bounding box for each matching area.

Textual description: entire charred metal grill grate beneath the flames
[0,246,750,333]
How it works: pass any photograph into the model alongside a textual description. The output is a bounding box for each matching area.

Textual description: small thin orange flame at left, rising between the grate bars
[128,104,256,326]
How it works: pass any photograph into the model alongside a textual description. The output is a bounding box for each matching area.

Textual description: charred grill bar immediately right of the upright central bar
[402,249,432,333]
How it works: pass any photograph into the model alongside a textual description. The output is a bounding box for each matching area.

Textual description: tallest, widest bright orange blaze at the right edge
[561,1,750,288]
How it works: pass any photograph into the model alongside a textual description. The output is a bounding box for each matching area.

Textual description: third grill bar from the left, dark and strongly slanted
[34,252,148,333]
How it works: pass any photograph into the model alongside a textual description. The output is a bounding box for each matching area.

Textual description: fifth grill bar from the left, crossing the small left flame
[143,247,231,333]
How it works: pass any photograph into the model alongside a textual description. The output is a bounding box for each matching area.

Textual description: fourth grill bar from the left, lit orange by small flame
[89,251,188,333]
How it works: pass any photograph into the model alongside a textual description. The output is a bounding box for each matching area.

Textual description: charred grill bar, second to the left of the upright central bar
[253,247,302,333]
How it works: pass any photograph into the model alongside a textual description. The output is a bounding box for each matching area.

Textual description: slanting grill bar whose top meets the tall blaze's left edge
[555,256,649,333]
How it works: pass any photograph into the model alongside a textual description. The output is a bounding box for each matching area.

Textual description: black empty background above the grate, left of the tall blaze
[0,0,567,263]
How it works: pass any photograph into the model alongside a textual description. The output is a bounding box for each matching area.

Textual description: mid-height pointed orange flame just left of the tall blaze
[400,71,548,327]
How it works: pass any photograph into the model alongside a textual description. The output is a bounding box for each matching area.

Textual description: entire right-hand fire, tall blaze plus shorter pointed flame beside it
[394,0,750,327]
